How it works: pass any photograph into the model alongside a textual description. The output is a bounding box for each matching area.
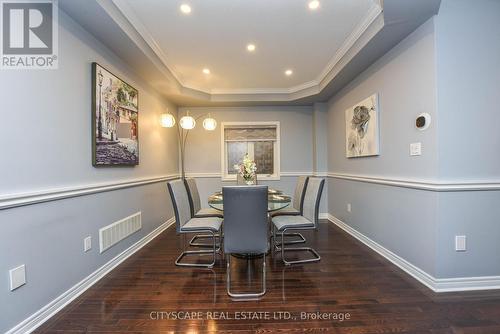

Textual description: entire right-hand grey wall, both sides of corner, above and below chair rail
[328,0,500,278]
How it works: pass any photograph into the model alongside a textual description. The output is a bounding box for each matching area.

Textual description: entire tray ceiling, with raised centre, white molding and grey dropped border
[59,0,440,106]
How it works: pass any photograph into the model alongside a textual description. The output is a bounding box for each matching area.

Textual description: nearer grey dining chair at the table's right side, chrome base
[272,177,325,265]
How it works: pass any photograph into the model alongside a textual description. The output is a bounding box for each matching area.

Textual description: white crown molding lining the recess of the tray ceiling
[107,0,383,101]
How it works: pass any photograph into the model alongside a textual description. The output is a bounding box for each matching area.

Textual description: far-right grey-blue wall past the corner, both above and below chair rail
[436,0,500,277]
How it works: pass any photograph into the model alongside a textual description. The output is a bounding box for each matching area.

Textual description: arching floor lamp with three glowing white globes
[160,110,217,179]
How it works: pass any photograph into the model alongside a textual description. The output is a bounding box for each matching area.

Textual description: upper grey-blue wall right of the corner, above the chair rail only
[436,0,500,181]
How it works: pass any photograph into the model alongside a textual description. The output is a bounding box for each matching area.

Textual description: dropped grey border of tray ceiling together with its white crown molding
[59,0,441,107]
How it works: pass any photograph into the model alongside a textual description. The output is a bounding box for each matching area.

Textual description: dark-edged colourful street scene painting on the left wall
[92,63,139,167]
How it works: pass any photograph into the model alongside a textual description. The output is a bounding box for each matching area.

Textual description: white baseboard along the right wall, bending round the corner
[326,213,500,292]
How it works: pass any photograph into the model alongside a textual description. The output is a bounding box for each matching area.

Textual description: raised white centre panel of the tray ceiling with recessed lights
[113,0,381,94]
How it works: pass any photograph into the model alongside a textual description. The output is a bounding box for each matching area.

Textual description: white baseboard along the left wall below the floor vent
[5,217,175,334]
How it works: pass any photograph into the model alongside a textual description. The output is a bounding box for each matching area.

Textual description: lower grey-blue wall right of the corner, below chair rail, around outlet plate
[436,191,500,278]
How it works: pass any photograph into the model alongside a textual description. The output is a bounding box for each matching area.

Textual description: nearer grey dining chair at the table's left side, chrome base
[167,179,222,268]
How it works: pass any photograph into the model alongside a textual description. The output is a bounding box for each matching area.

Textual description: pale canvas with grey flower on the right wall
[345,94,380,158]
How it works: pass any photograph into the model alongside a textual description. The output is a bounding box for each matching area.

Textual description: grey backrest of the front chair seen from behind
[222,186,269,254]
